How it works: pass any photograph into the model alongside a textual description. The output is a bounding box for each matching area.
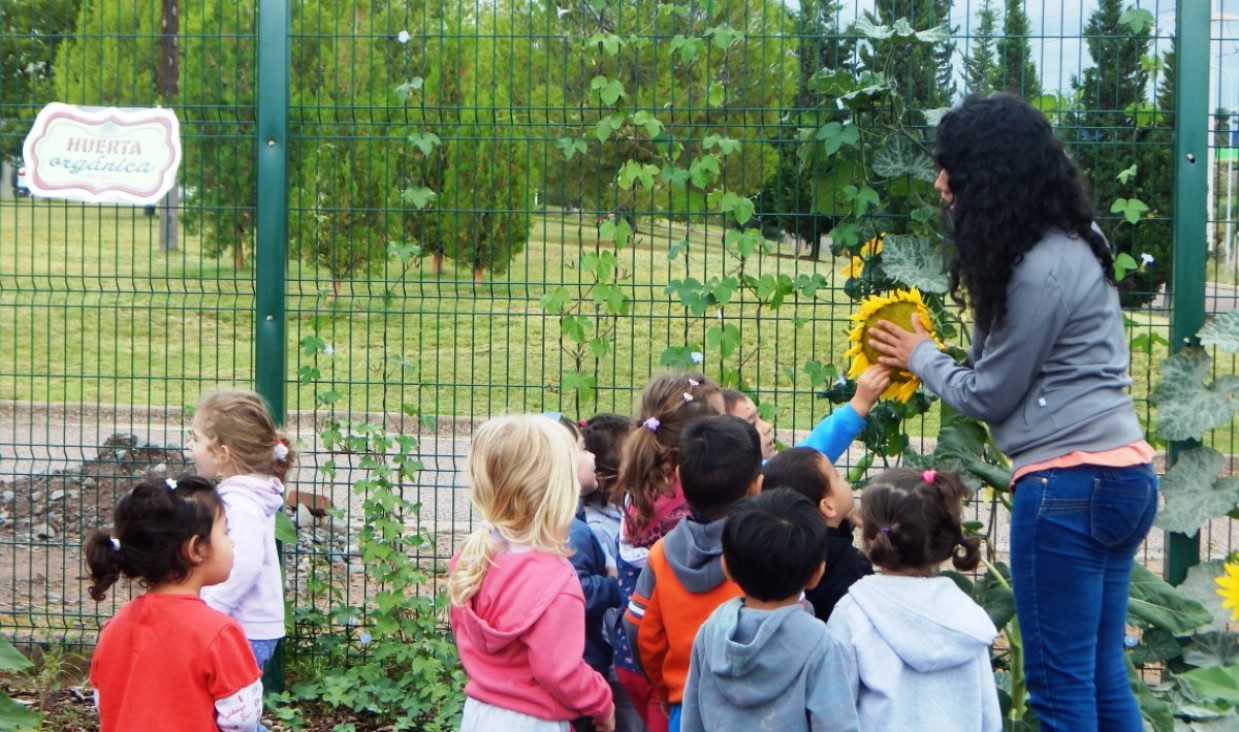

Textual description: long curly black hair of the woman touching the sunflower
[934,94,1116,331]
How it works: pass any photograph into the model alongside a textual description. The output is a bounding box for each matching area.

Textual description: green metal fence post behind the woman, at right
[1165,0,1212,585]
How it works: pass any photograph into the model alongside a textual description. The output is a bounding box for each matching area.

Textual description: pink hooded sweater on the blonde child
[451,551,612,721]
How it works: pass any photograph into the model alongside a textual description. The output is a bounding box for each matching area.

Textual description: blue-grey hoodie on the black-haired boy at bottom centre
[680,597,857,732]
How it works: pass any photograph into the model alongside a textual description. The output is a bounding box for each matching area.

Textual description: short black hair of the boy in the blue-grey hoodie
[722,488,826,602]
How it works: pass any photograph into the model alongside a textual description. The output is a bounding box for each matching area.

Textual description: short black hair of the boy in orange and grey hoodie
[679,415,762,519]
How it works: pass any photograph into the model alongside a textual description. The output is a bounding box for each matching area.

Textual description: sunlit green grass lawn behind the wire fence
[0,199,877,429]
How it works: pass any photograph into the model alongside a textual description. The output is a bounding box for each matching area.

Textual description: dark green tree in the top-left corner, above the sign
[0,0,82,160]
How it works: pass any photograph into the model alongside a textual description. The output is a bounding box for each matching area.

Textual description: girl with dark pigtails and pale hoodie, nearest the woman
[826,468,1002,732]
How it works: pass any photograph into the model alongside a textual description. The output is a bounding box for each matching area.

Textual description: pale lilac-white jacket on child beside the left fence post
[202,476,284,640]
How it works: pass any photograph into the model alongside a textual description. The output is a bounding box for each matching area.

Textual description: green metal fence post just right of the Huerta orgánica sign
[254,0,290,691]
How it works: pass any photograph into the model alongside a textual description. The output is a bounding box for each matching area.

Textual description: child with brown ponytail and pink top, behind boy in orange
[613,372,724,732]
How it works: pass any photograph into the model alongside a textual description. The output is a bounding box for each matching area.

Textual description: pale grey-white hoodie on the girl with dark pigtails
[826,575,1002,732]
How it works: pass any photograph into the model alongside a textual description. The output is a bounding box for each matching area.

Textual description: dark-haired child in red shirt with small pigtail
[85,477,263,732]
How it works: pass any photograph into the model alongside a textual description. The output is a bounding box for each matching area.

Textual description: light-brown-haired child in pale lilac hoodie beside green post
[190,389,294,688]
